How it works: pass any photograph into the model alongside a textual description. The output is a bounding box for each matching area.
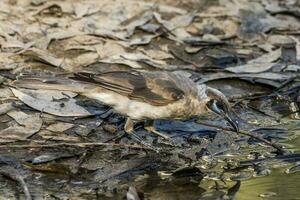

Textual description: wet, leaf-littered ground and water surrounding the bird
[0,0,300,200]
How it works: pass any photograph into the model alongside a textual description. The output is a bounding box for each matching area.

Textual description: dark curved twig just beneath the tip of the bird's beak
[197,121,285,153]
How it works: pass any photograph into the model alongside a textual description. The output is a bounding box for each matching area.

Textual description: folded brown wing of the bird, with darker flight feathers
[70,71,184,106]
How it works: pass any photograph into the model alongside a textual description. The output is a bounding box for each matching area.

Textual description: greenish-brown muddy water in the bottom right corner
[136,120,300,200]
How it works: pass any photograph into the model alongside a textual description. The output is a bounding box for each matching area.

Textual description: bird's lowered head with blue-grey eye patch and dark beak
[205,87,239,132]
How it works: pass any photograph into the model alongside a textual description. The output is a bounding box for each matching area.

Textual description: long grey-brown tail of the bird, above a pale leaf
[11,75,95,93]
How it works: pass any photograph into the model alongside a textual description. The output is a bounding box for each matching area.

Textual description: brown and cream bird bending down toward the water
[11,71,239,149]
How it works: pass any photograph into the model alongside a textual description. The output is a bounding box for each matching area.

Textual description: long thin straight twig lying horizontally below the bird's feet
[0,141,153,150]
